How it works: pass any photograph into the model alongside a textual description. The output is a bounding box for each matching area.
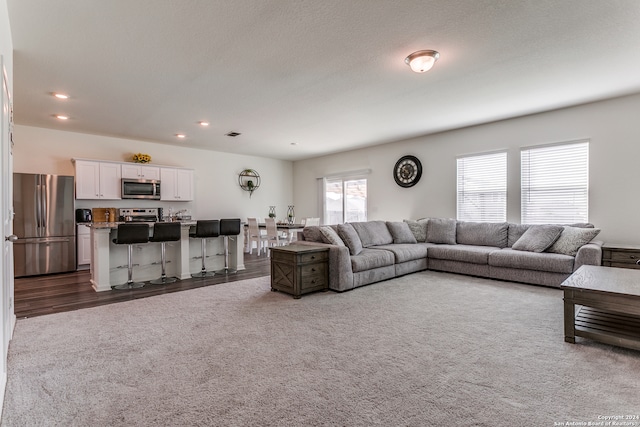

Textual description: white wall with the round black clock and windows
[293,94,640,244]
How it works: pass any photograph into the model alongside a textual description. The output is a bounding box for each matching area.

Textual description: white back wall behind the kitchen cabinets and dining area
[14,126,293,219]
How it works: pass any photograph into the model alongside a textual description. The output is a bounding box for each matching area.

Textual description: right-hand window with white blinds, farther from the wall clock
[520,141,589,224]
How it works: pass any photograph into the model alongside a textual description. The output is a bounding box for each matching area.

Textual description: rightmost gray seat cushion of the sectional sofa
[489,248,574,273]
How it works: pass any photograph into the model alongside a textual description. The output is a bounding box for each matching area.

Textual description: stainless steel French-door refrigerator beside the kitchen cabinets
[13,173,76,277]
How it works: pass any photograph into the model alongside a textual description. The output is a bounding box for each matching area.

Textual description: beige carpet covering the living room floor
[2,272,640,426]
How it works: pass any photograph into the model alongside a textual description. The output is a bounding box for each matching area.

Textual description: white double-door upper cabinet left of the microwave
[75,160,122,200]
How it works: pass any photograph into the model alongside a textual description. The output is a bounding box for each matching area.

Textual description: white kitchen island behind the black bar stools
[89,221,245,292]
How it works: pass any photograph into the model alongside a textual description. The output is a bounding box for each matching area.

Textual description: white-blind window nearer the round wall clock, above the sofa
[457,152,507,222]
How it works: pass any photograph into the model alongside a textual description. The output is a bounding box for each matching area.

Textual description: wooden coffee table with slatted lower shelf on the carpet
[560,265,640,350]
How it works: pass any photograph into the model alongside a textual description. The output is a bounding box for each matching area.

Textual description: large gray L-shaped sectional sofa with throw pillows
[296,218,602,291]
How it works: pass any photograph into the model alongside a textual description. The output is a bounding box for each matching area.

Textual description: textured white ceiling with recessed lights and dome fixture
[8,0,640,160]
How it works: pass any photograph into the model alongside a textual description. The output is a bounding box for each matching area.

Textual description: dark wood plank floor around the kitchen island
[15,254,270,319]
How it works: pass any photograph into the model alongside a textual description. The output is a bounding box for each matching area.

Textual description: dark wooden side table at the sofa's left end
[271,245,329,299]
